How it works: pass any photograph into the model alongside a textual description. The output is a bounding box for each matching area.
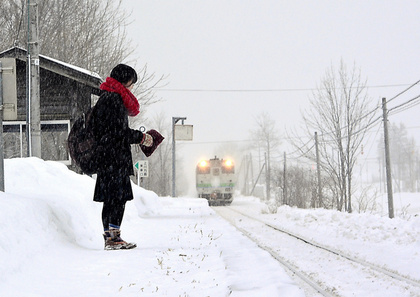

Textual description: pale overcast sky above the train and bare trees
[120,0,420,192]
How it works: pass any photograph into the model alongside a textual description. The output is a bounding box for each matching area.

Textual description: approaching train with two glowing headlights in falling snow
[195,157,236,206]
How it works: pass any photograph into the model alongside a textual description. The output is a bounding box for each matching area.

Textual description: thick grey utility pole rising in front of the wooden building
[26,0,41,158]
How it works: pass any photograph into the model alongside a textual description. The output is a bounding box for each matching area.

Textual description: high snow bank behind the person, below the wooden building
[0,158,160,275]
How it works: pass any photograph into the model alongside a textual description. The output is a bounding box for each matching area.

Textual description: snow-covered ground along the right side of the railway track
[232,193,420,284]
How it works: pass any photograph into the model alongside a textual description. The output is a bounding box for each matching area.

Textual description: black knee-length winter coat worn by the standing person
[92,91,143,202]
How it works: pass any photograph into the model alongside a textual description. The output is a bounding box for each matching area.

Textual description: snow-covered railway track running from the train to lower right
[213,207,420,297]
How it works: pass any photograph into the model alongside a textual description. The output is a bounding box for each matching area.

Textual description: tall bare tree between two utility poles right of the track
[295,61,377,212]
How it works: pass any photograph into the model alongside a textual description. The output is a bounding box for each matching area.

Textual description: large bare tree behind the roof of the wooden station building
[0,0,165,121]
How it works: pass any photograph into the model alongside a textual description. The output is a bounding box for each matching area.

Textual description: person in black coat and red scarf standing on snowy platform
[92,64,153,250]
